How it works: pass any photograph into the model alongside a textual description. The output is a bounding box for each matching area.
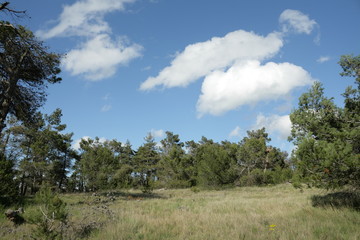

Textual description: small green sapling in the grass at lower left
[25,186,68,239]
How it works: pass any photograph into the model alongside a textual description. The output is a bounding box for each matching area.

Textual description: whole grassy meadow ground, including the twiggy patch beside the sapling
[0,185,360,240]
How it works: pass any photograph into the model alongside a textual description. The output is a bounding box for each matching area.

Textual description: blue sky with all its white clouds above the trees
[5,0,360,151]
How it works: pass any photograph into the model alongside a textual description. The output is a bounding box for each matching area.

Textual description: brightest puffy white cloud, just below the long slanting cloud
[197,61,313,117]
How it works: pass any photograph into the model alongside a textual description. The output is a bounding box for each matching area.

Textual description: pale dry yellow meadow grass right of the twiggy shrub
[91,185,360,240]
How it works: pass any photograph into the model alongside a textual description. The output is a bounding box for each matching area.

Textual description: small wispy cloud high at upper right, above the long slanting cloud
[279,9,317,34]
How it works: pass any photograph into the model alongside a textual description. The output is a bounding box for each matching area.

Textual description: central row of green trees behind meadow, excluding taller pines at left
[71,129,290,191]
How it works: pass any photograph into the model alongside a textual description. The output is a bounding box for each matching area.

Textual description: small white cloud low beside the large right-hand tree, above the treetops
[253,114,291,139]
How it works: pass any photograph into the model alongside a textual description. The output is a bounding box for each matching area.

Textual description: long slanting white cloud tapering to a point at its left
[140,30,283,90]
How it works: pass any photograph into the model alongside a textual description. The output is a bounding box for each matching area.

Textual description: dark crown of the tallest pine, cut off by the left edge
[0,21,61,133]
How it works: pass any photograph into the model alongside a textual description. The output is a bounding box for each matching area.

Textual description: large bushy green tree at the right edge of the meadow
[290,56,360,189]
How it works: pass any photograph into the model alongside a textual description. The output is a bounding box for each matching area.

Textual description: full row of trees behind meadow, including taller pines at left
[3,109,291,196]
